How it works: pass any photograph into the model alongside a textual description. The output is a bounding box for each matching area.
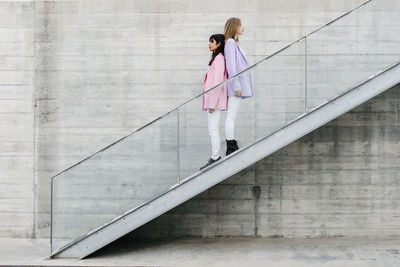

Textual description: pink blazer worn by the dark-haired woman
[202,53,228,110]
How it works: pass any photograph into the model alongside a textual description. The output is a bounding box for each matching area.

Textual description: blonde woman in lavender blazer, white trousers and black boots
[224,18,253,156]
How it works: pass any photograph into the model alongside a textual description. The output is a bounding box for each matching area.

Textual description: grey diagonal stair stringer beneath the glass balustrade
[51,62,400,259]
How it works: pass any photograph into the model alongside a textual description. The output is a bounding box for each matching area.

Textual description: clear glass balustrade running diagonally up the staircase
[51,0,400,254]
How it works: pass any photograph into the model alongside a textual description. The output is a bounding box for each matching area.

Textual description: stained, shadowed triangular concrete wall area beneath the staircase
[127,85,400,238]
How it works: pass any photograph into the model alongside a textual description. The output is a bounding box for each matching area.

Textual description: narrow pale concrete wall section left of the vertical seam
[0,2,35,237]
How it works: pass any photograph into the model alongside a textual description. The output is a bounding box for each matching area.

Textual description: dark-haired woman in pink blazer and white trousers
[200,34,228,170]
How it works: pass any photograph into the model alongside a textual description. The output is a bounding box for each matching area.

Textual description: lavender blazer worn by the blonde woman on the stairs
[224,38,253,98]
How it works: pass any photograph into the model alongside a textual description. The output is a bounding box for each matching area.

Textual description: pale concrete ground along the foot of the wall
[0,238,400,267]
